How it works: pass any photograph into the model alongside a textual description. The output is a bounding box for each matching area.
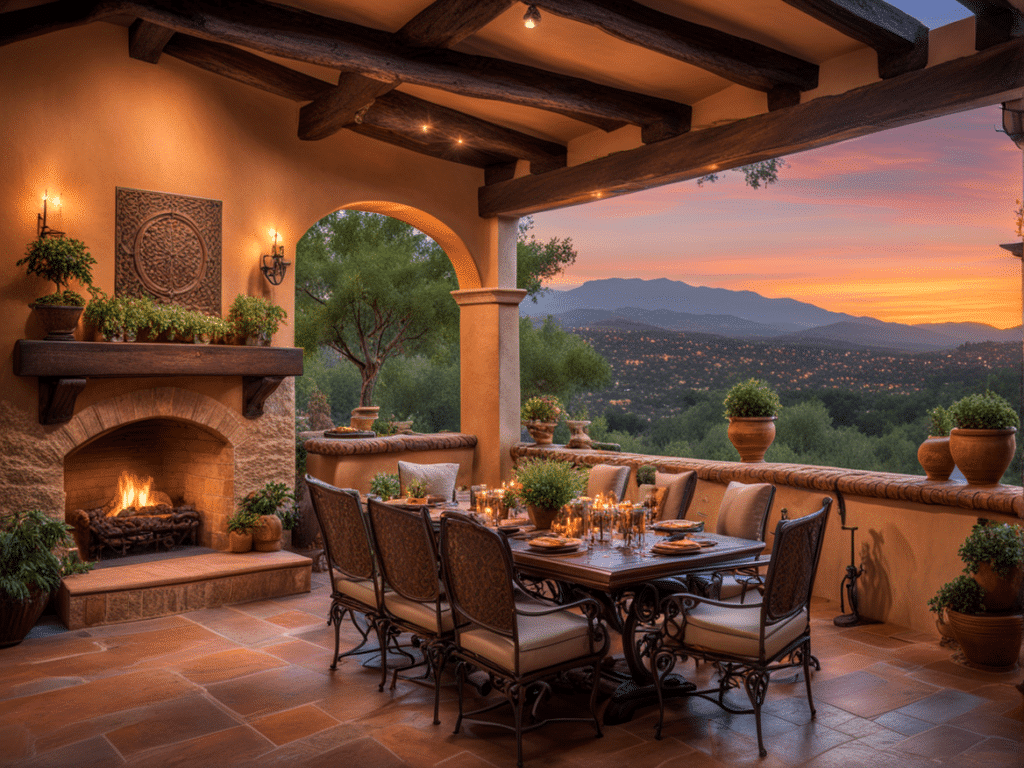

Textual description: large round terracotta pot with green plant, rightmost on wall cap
[949,390,1020,485]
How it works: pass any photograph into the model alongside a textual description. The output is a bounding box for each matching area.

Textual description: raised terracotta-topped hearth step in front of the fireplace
[56,551,312,630]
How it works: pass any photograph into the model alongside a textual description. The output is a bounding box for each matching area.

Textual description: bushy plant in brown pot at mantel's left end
[17,236,96,341]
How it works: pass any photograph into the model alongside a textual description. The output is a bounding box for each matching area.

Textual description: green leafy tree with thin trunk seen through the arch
[296,211,458,406]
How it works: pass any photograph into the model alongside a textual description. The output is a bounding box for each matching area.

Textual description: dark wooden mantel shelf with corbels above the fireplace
[14,339,302,424]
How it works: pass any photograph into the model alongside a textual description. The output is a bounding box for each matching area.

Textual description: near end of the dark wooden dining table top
[509,534,765,593]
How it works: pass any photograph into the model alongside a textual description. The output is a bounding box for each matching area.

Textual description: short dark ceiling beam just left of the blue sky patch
[785,0,928,79]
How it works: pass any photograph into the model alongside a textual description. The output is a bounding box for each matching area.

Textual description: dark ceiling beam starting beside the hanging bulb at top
[536,0,818,91]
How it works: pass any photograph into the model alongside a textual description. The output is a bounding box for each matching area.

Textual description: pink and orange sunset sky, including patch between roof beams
[535,0,1022,328]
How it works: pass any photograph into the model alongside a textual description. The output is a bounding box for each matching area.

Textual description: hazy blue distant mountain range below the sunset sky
[519,278,1021,352]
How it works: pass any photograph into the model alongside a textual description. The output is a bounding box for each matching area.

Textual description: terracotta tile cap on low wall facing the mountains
[512,442,1024,518]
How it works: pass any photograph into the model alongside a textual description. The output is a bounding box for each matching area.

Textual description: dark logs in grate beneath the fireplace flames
[66,504,201,560]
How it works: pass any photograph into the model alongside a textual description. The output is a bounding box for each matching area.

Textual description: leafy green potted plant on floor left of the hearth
[0,509,92,648]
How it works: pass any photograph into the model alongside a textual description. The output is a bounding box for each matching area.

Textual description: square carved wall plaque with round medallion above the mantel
[114,186,222,316]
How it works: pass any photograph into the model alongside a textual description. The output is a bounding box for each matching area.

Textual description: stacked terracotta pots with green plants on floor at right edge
[928,523,1024,670]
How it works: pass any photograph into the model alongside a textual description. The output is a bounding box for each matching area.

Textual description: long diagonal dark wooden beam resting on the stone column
[479,39,1024,218]
